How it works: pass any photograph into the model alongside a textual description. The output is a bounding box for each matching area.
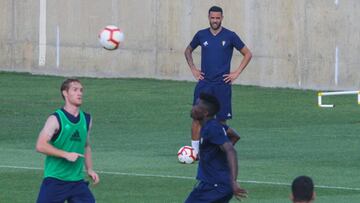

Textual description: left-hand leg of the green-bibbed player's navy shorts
[36,178,71,203]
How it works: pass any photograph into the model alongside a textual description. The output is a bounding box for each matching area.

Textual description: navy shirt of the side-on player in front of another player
[196,119,231,185]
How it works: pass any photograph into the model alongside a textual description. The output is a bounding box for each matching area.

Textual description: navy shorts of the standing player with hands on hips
[193,80,232,121]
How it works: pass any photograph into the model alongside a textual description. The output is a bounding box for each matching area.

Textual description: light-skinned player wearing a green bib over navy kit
[36,79,100,203]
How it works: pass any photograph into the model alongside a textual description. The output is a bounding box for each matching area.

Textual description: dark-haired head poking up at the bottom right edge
[291,176,314,201]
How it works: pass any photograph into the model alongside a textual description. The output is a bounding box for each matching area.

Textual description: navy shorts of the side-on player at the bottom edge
[185,181,233,203]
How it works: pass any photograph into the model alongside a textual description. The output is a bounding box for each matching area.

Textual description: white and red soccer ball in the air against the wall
[99,25,124,50]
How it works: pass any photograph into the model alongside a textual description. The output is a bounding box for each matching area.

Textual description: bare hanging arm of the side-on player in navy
[220,142,247,200]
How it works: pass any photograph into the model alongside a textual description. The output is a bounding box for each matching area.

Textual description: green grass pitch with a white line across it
[0,72,360,203]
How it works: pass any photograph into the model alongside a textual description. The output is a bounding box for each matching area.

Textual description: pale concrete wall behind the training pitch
[0,0,360,90]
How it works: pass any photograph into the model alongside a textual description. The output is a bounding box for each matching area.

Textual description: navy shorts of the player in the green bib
[37,177,95,203]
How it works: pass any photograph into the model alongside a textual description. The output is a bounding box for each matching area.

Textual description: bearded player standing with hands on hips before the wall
[185,6,252,154]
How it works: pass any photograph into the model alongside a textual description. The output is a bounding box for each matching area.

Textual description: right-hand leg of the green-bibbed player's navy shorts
[68,181,95,203]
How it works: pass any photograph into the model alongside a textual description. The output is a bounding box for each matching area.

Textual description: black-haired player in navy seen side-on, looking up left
[185,93,247,203]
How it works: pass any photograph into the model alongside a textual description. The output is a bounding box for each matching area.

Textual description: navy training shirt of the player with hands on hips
[190,27,245,82]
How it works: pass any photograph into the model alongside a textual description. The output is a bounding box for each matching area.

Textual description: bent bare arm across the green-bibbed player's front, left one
[36,115,83,162]
